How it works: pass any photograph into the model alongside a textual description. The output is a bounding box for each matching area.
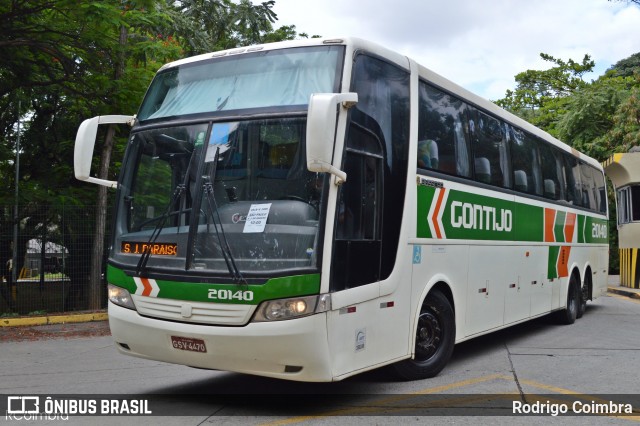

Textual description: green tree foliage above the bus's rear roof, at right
[496,53,640,161]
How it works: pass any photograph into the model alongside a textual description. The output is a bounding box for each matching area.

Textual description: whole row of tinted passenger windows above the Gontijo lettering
[417,81,608,213]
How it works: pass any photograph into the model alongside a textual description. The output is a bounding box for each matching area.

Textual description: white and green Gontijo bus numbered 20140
[75,38,608,381]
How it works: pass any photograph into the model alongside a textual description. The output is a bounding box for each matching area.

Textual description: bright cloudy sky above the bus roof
[264,0,640,100]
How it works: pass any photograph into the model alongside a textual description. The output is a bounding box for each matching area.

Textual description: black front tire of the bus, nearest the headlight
[393,290,456,380]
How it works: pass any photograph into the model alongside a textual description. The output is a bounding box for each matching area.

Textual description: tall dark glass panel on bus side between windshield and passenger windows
[331,54,410,290]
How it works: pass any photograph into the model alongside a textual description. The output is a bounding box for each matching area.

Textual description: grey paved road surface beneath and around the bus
[0,295,640,425]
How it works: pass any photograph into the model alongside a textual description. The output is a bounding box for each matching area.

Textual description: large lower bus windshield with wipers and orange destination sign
[112,118,324,278]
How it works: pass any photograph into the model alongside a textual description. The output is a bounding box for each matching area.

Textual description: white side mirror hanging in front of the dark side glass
[307,93,358,183]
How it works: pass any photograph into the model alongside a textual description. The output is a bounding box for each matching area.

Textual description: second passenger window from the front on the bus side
[468,108,511,188]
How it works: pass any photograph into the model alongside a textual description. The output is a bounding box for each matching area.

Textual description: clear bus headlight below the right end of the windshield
[253,294,331,322]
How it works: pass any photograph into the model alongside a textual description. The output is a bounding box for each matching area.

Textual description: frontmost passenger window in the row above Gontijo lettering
[417,82,471,177]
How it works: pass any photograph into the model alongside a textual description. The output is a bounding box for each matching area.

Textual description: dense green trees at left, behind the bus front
[0,0,314,307]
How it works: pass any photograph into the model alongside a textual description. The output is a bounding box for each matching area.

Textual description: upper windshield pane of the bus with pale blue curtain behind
[138,46,344,121]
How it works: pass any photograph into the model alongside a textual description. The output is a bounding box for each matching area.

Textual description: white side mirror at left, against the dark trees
[73,115,135,188]
